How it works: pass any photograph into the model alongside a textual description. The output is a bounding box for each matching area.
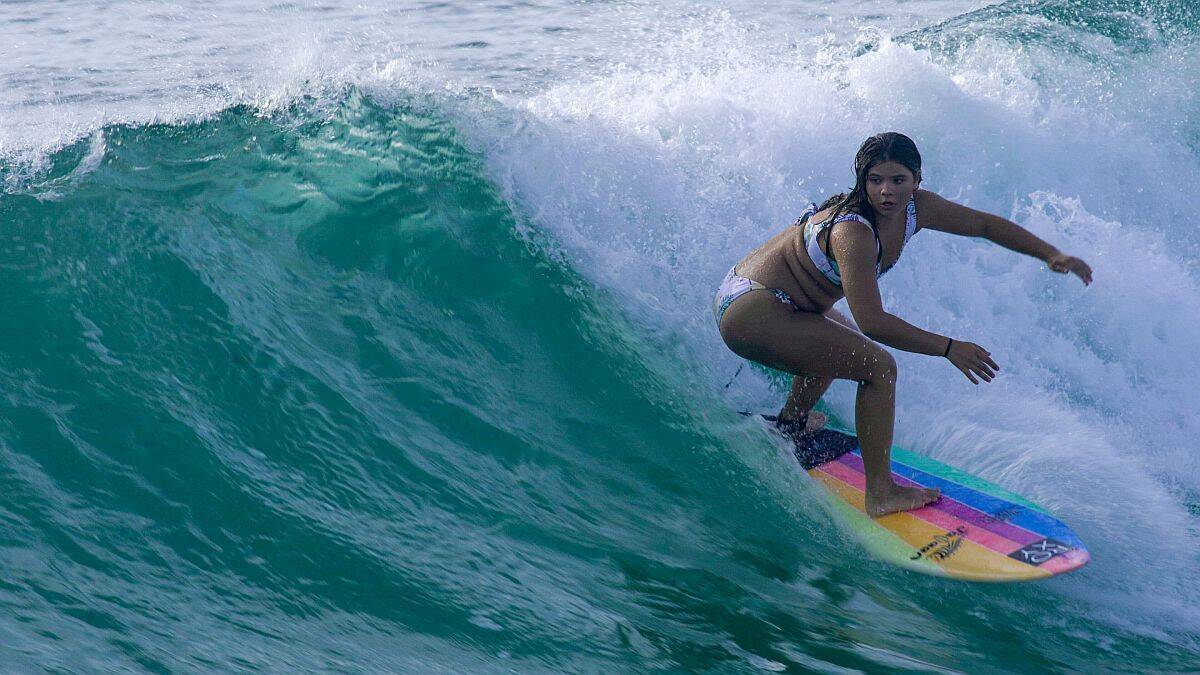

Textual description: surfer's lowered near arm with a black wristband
[829,221,1000,384]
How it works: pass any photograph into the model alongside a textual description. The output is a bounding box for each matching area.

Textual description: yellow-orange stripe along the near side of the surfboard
[809,468,1050,581]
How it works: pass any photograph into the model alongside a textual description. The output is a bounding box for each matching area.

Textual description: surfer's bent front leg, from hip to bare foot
[720,291,938,516]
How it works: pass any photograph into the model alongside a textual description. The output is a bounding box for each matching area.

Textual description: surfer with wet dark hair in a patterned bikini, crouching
[713,132,1092,518]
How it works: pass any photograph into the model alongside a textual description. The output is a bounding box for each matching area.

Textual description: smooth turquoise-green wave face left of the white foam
[0,92,1194,671]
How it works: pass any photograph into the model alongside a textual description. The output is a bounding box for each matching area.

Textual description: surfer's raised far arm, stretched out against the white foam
[918,190,1092,285]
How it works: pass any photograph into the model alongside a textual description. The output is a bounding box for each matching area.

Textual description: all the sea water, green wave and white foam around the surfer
[0,0,1200,673]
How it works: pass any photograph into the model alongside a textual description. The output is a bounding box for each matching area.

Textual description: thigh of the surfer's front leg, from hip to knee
[721,291,896,382]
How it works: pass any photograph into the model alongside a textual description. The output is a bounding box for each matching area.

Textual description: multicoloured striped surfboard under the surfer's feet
[760,418,1091,581]
